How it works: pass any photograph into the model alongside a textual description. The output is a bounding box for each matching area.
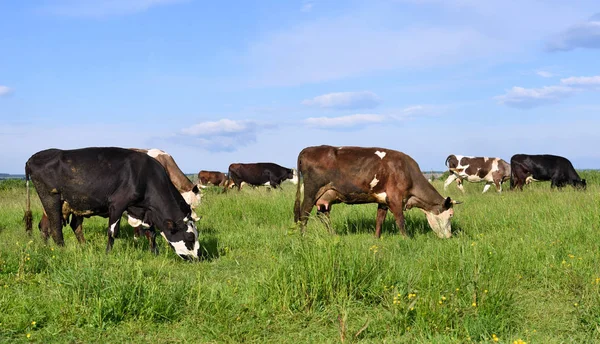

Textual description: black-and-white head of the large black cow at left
[160,216,200,260]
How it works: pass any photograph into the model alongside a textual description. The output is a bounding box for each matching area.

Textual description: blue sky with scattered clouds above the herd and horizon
[0,0,600,174]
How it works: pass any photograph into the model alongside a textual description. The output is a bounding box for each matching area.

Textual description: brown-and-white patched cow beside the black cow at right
[444,154,510,192]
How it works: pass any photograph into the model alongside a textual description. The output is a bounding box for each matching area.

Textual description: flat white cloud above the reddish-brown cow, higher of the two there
[302,91,381,109]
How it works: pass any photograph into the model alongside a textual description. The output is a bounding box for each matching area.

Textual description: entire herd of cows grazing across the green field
[25,145,586,260]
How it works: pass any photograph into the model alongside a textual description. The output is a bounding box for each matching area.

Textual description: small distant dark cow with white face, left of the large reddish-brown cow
[223,162,298,191]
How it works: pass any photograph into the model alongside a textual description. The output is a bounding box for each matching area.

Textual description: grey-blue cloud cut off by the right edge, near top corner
[546,13,600,51]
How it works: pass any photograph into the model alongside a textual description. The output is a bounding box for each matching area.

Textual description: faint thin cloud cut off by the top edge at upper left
[44,0,187,17]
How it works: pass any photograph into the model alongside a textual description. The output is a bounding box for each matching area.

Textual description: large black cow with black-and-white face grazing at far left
[25,147,200,259]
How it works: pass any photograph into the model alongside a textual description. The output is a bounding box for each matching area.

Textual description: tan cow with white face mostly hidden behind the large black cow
[38,148,202,243]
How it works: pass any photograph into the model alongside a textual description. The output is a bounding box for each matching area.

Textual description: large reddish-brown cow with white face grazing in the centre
[294,146,459,238]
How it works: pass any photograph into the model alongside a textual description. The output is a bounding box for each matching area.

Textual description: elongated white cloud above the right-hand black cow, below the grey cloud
[495,86,576,109]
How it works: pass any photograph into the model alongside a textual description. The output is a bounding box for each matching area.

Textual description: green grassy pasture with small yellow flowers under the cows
[0,171,600,343]
